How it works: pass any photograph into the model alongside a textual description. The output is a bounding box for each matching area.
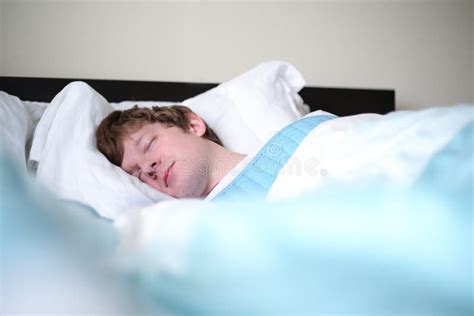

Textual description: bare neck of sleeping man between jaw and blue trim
[205,142,245,196]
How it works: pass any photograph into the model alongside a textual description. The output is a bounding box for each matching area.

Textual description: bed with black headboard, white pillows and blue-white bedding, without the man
[0,62,474,315]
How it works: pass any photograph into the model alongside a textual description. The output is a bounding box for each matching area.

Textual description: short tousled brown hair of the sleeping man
[95,105,222,166]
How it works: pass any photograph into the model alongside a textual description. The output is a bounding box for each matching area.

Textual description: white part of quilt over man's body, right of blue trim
[267,105,474,200]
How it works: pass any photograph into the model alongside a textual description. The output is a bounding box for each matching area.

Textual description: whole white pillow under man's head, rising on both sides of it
[30,62,307,219]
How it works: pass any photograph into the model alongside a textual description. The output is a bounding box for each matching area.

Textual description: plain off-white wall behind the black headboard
[1,0,474,109]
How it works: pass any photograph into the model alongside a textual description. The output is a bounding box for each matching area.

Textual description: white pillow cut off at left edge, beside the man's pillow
[0,91,33,174]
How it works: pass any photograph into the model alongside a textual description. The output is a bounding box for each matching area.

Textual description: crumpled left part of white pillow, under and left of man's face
[30,82,171,219]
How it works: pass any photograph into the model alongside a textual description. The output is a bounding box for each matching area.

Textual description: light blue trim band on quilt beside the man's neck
[213,115,337,201]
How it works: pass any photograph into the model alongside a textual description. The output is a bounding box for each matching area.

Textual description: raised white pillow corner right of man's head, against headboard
[183,61,309,154]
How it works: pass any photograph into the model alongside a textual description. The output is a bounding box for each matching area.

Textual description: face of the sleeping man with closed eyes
[121,123,209,198]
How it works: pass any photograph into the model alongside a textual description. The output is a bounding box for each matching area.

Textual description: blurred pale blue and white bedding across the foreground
[0,123,474,315]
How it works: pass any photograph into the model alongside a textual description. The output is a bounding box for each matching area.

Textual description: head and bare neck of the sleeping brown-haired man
[96,105,244,198]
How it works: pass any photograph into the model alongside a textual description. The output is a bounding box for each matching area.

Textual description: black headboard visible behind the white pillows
[0,77,395,116]
